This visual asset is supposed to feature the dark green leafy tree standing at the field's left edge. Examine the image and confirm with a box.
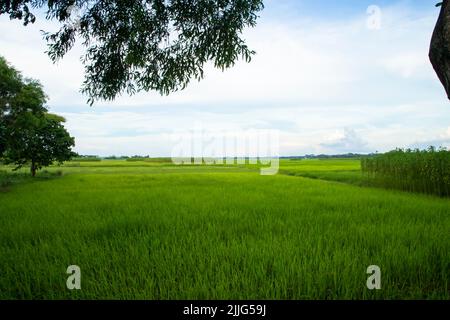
[0,57,75,176]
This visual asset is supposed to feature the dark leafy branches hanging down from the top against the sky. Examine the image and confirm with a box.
[0,0,263,104]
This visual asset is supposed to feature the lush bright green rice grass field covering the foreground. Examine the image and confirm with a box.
[0,160,450,299]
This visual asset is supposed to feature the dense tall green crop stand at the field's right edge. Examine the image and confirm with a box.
[361,147,450,196]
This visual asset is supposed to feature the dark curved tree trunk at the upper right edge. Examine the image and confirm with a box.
[429,0,450,99]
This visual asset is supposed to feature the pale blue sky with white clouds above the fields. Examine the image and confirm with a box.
[0,0,450,157]
